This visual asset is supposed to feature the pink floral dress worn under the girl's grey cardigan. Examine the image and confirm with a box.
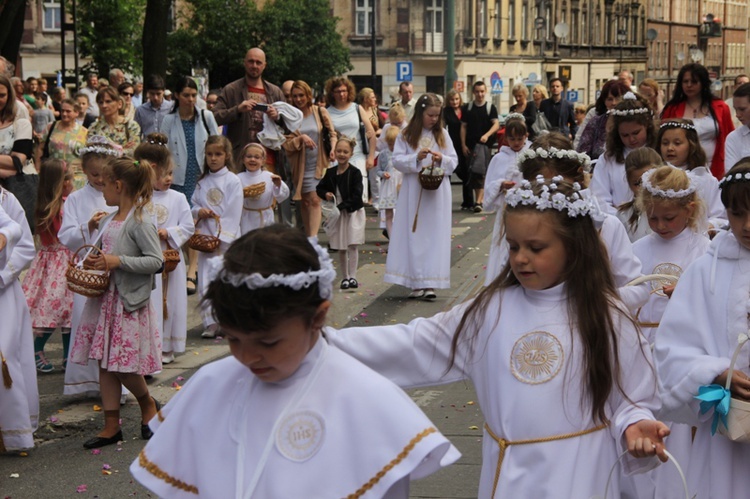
[70,220,161,375]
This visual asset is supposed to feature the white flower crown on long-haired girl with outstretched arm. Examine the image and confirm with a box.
[505,175,602,220]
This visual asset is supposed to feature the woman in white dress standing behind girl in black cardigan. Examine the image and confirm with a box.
[325,77,377,203]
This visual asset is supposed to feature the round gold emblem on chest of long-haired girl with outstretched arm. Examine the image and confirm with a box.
[510,331,565,385]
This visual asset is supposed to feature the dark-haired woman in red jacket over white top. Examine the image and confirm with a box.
[661,64,734,180]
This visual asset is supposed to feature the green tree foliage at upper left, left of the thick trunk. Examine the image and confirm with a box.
[75,0,146,77]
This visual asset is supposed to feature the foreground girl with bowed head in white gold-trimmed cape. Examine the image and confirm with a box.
[130,228,460,499]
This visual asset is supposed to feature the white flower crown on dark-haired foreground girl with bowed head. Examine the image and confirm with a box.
[207,237,336,300]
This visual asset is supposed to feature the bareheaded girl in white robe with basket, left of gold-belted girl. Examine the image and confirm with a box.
[191,135,242,338]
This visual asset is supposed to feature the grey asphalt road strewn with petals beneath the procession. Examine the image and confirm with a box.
[0,185,494,499]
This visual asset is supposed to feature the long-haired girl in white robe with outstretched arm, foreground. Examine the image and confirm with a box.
[326,177,669,499]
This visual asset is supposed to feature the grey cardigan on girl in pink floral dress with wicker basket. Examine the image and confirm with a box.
[99,212,164,312]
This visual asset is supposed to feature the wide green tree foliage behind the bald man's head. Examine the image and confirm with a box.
[168,0,352,88]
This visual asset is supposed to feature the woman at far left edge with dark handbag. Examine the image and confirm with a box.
[0,76,39,231]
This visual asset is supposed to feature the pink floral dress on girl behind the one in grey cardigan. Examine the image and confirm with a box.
[23,211,73,329]
